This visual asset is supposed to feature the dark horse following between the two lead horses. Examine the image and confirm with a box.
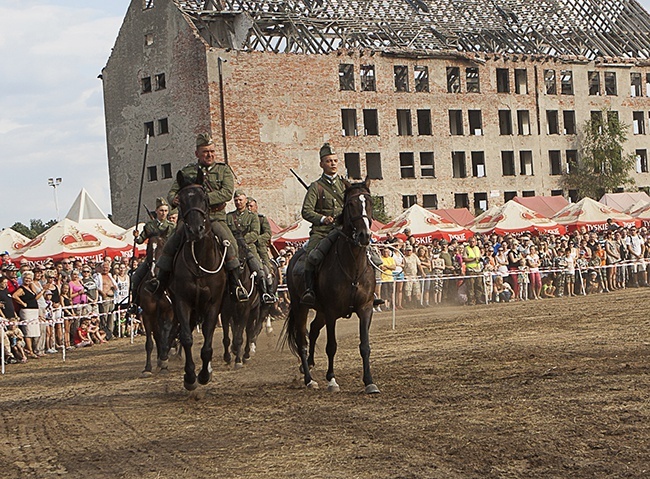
[221,238,261,369]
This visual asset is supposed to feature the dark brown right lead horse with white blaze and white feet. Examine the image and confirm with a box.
[283,179,379,394]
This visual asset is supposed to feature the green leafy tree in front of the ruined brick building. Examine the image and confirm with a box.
[564,108,635,200]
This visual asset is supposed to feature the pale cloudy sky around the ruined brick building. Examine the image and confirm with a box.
[0,0,650,229]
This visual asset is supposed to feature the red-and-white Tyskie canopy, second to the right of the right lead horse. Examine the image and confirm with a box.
[469,200,565,235]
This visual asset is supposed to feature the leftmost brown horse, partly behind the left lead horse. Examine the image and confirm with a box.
[138,231,175,377]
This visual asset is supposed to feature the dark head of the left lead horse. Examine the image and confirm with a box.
[176,168,211,241]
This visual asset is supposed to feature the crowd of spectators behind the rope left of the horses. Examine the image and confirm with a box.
[0,253,140,364]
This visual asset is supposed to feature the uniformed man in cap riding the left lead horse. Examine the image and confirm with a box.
[147,133,248,301]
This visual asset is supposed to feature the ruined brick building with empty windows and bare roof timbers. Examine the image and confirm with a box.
[102,0,650,226]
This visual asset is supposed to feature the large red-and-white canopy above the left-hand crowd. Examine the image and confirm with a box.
[16,218,132,263]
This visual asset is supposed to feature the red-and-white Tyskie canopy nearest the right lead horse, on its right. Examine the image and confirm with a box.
[377,204,473,244]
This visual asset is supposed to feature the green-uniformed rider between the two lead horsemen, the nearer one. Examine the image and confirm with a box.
[226,190,276,303]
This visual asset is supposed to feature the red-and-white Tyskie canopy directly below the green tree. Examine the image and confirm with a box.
[553,198,641,231]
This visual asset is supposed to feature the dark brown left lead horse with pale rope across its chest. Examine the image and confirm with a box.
[169,169,228,391]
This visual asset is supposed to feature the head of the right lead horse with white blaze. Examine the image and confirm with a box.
[342,178,372,246]
